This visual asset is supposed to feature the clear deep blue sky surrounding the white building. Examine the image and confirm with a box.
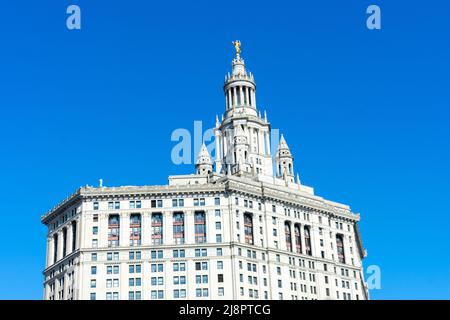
[0,0,450,299]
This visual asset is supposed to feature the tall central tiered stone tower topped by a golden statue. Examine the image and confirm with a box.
[215,41,273,177]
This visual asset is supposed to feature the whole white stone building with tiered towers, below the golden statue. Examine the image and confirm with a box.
[42,45,368,300]
